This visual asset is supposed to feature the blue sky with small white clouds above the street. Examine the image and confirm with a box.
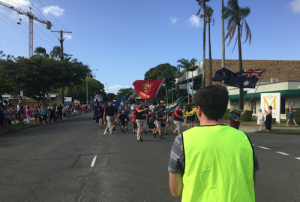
[0,0,300,93]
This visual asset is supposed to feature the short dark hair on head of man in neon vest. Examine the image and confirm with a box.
[195,85,229,121]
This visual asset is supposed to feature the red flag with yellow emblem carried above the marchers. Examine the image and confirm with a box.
[133,79,164,100]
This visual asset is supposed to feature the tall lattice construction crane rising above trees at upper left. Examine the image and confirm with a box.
[0,1,52,57]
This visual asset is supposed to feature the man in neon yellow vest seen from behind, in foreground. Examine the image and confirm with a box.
[168,85,259,202]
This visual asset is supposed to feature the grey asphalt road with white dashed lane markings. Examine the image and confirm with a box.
[0,113,300,202]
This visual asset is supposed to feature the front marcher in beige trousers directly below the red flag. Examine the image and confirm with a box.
[135,102,148,142]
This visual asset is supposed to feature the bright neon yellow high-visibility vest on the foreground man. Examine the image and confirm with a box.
[182,125,255,202]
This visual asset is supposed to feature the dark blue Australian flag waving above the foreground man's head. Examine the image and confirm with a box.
[213,68,265,88]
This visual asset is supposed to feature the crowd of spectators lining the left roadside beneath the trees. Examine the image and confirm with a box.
[0,102,93,134]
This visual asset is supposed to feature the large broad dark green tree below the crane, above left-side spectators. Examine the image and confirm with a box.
[5,55,89,104]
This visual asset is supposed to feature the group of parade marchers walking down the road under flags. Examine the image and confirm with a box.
[93,100,195,142]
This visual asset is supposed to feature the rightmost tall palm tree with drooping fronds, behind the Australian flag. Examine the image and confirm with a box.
[222,0,252,109]
